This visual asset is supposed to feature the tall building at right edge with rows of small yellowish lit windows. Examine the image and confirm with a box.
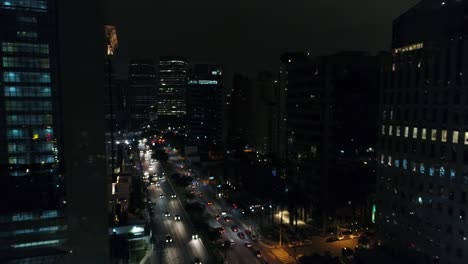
[375,0,468,264]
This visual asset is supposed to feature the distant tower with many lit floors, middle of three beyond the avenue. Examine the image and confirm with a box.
[156,56,189,130]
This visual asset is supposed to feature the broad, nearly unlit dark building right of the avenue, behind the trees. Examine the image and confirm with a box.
[279,52,378,227]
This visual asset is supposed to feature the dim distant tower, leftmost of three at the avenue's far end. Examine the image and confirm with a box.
[126,59,157,129]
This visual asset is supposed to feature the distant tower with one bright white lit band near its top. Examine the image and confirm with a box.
[186,64,223,146]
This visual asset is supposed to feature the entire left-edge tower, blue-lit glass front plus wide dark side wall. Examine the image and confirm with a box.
[0,0,108,264]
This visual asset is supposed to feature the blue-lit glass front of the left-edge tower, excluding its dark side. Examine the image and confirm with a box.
[0,0,68,263]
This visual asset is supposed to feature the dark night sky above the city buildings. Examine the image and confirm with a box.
[104,0,419,77]
